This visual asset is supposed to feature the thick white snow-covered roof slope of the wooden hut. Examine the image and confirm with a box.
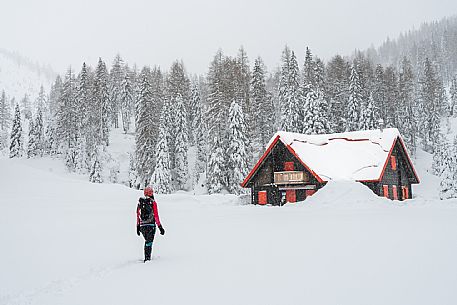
[268,128,401,181]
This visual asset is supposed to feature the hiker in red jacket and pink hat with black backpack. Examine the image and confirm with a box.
[136,186,165,262]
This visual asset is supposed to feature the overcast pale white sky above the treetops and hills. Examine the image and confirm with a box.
[0,0,457,73]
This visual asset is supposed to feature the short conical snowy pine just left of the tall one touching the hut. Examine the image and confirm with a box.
[206,133,227,194]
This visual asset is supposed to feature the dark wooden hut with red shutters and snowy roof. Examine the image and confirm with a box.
[241,128,419,205]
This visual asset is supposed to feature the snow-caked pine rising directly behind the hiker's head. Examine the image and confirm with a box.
[150,113,173,194]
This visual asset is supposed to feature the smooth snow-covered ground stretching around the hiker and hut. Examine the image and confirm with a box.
[0,153,457,305]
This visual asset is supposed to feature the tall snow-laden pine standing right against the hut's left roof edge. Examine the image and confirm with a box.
[227,101,248,194]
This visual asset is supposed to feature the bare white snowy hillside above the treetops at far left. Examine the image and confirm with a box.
[0,49,55,102]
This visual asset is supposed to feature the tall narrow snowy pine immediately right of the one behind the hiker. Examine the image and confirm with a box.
[174,93,189,190]
